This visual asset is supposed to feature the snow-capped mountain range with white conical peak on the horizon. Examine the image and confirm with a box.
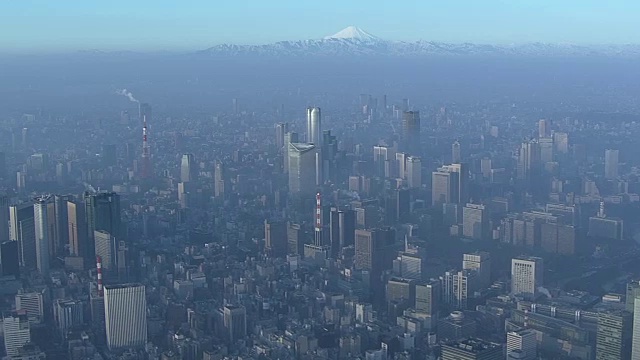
[197,26,640,58]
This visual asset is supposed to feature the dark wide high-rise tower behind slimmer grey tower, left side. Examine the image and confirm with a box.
[84,192,122,262]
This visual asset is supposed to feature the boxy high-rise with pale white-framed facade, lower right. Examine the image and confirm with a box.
[511,256,544,300]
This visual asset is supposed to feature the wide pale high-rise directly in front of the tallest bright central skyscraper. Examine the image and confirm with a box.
[289,143,317,196]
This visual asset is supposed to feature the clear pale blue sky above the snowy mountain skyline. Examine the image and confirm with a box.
[0,0,640,52]
